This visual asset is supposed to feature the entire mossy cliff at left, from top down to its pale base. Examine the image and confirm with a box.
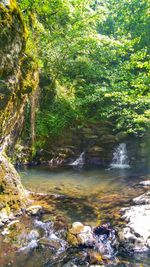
[0,0,38,214]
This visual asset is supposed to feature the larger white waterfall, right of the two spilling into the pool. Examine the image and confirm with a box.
[110,143,130,169]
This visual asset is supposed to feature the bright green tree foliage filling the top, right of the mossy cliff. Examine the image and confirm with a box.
[19,0,150,144]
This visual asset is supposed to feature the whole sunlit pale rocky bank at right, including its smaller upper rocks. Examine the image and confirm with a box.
[119,180,150,253]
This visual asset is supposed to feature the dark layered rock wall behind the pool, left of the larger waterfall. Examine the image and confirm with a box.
[36,122,118,166]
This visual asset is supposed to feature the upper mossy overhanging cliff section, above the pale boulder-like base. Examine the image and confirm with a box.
[0,0,38,150]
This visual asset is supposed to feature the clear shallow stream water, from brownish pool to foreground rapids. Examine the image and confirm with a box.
[0,163,150,267]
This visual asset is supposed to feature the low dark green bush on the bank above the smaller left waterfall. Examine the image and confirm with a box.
[36,98,77,146]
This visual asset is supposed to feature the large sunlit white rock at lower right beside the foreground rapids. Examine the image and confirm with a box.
[119,205,150,252]
